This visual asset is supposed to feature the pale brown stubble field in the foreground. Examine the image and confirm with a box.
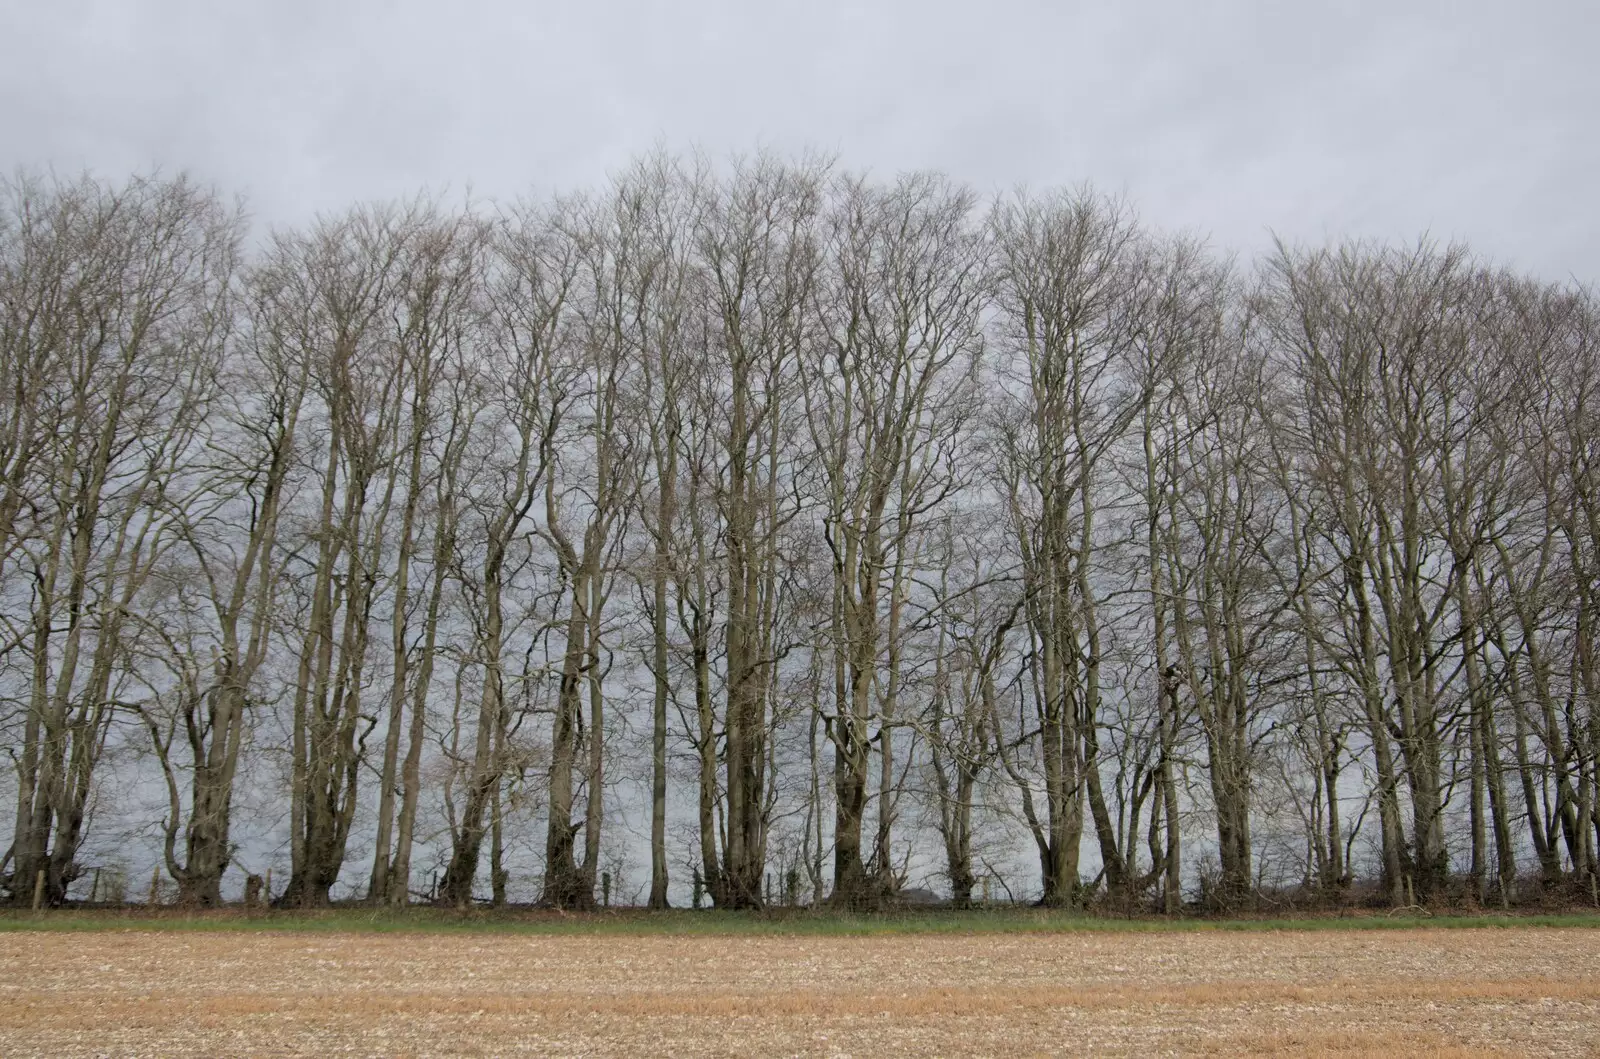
[0,928,1600,1059]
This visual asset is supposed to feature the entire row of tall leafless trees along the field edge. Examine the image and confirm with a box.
[0,155,1600,910]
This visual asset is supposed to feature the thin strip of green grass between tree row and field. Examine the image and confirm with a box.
[0,909,1600,937]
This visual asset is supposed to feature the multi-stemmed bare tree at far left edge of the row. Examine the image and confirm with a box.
[0,178,240,904]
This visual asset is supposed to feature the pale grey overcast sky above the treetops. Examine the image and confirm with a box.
[0,0,1600,282]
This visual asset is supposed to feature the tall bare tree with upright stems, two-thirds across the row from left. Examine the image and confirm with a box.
[989,190,1142,905]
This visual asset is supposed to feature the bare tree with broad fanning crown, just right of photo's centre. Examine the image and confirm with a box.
[803,174,984,907]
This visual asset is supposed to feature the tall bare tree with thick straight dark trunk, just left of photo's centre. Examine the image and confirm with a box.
[694,158,822,909]
